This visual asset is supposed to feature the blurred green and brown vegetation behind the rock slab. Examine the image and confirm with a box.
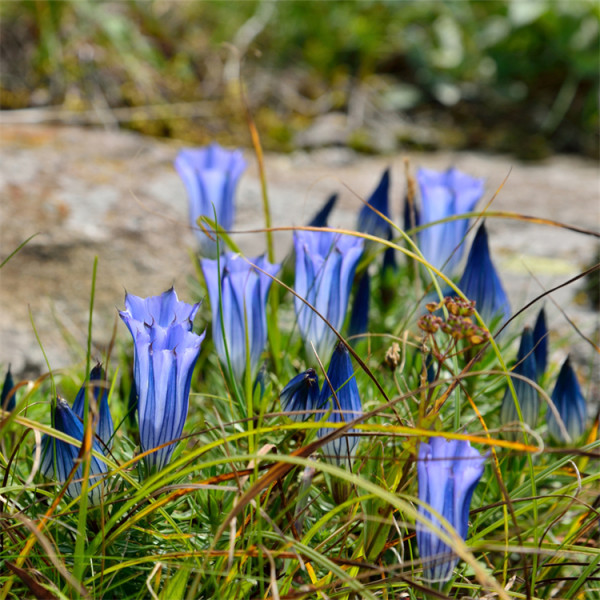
[0,0,600,158]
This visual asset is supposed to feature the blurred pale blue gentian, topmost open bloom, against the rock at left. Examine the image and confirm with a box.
[175,144,246,256]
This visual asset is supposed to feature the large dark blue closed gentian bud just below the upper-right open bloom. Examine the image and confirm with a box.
[458,223,510,327]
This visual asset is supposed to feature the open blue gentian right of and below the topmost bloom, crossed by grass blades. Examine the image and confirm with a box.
[201,252,280,380]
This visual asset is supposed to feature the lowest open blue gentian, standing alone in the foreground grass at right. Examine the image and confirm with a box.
[417,437,486,583]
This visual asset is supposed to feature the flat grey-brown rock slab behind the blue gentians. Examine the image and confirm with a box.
[0,123,600,398]
